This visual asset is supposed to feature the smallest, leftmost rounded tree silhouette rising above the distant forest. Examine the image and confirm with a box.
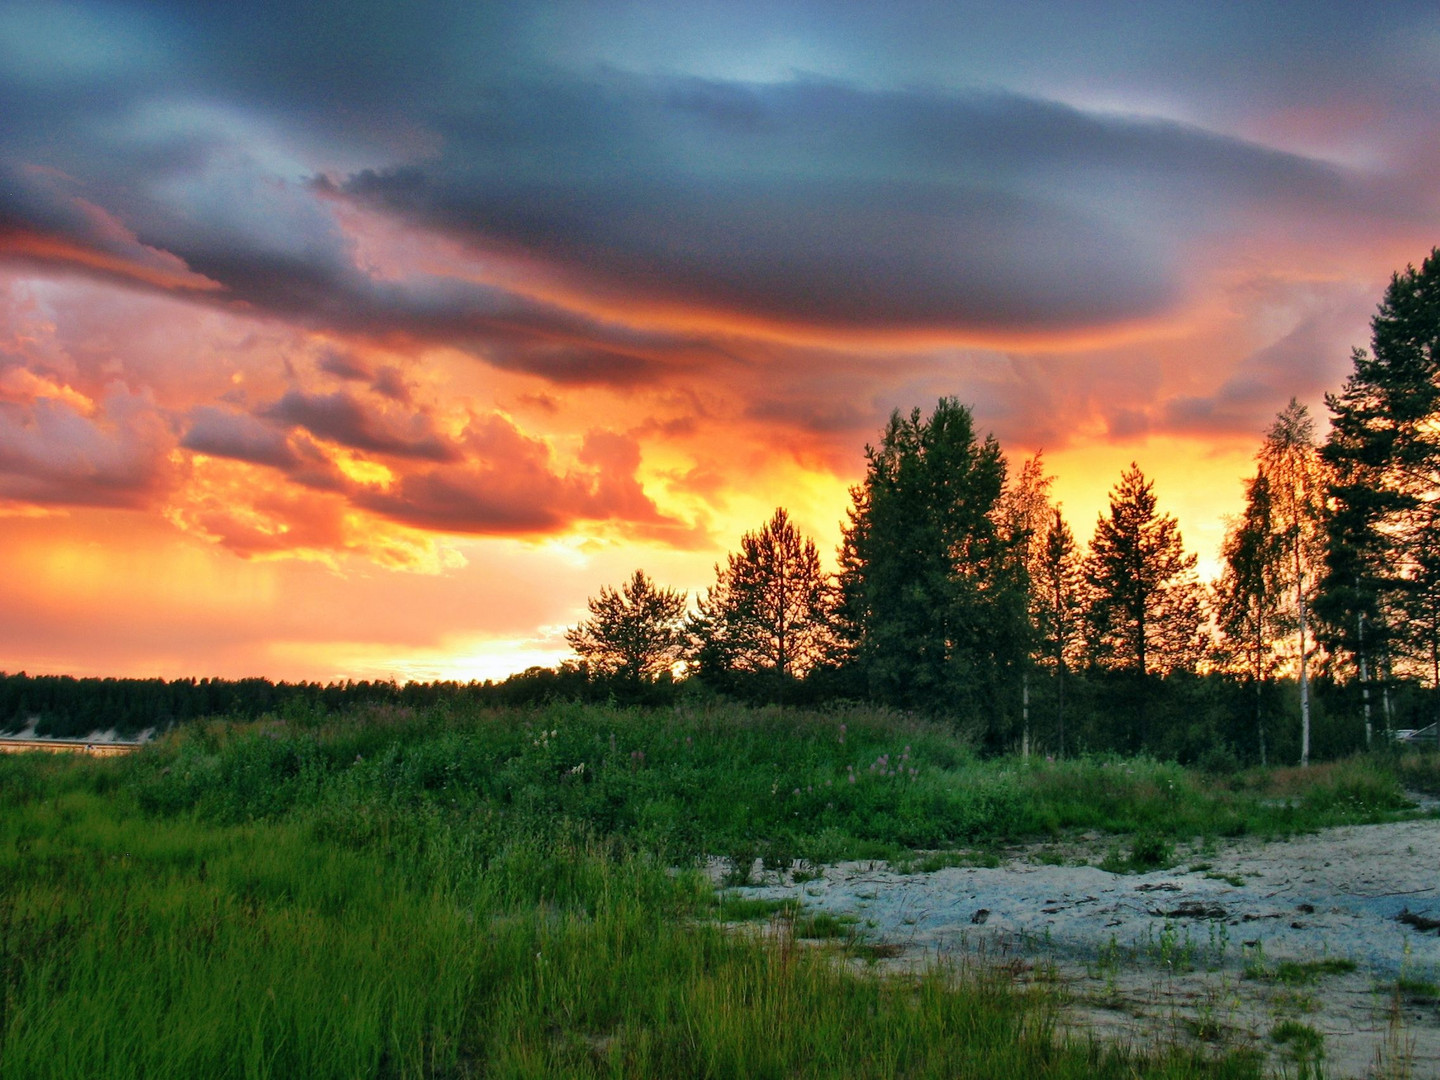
[564,570,685,683]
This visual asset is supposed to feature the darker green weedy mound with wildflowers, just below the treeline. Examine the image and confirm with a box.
[109,706,1407,864]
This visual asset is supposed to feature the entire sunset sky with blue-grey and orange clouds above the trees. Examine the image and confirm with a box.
[0,0,1440,681]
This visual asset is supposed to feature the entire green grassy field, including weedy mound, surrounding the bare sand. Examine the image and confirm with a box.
[0,706,1433,1080]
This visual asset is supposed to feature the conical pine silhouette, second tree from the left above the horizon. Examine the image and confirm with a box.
[691,508,835,681]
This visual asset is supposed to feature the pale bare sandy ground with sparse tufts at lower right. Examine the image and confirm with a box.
[731,819,1440,1077]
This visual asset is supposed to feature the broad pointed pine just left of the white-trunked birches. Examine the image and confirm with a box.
[1084,462,1202,675]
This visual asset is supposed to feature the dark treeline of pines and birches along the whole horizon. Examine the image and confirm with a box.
[8,251,1440,768]
